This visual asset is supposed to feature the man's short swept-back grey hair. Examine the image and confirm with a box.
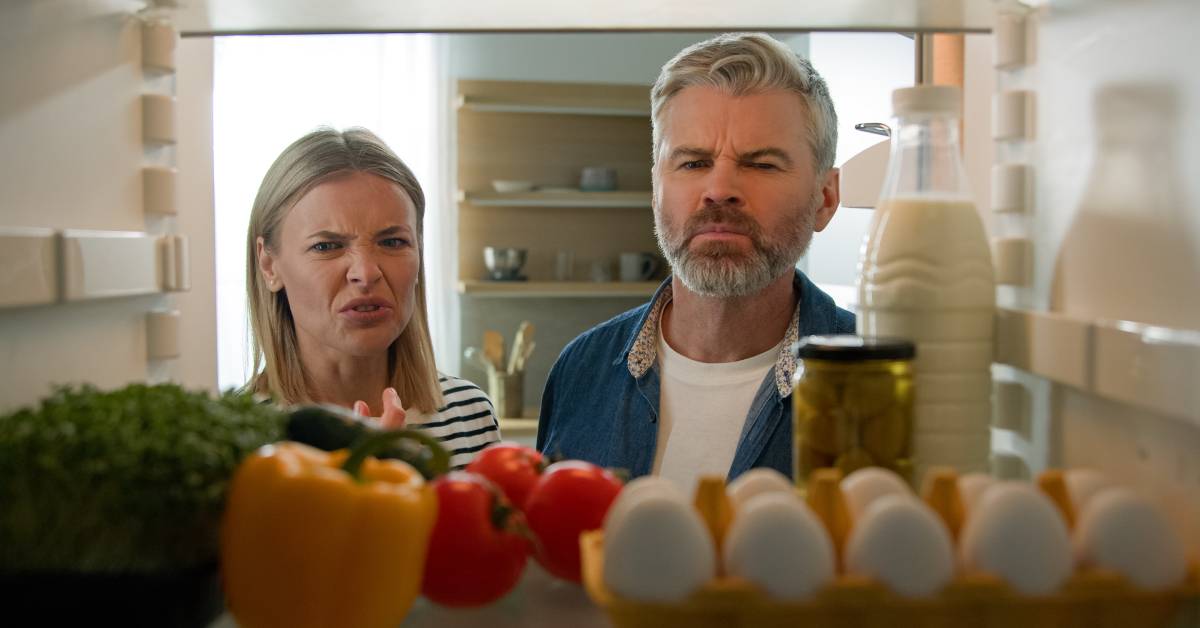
[650,32,838,172]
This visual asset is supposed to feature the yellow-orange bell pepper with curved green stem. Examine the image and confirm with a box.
[221,430,449,628]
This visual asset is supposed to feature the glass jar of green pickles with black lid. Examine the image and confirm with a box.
[792,335,917,488]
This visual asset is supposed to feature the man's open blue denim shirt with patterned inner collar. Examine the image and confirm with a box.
[538,270,854,480]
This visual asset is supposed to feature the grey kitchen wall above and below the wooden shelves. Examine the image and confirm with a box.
[448,32,808,417]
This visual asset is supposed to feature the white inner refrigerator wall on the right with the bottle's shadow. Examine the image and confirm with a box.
[1022,0,1200,557]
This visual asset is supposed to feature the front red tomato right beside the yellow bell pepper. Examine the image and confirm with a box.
[421,471,529,606]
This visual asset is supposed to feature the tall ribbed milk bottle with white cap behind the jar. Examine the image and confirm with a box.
[858,85,996,485]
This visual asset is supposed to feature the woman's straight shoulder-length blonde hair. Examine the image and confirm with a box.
[246,127,442,413]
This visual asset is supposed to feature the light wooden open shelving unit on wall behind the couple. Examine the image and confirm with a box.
[457,80,658,291]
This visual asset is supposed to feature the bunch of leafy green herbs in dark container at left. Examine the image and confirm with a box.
[0,384,284,573]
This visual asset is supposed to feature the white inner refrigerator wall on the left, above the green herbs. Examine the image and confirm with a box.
[0,0,216,412]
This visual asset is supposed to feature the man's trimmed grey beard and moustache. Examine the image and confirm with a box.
[654,189,821,298]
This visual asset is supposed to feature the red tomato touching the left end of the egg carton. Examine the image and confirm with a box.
[526,460,622,582]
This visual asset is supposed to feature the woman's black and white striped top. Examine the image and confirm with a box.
[406,373,500,468]
